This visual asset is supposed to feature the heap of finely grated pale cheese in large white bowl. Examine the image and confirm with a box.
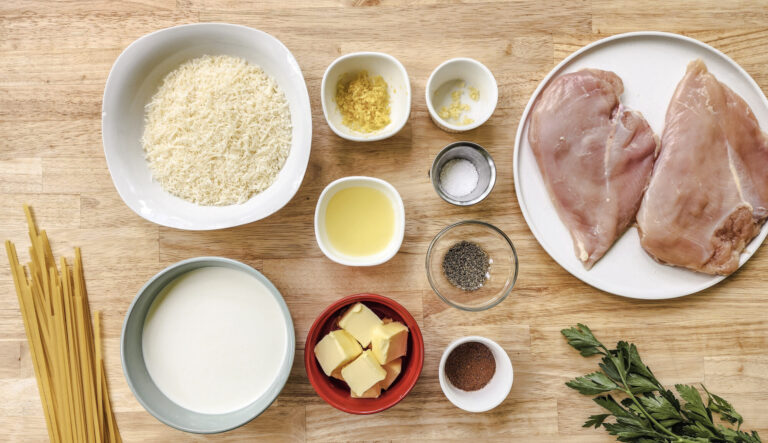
[142,55,292,206]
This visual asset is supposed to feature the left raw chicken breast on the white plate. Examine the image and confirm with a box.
[528,69,658,269]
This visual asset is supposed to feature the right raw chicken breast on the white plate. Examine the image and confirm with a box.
[637,60,768,275]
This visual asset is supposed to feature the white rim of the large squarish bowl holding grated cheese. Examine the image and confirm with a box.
[101,22,312,231]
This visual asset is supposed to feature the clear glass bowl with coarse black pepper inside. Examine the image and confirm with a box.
[426,220,518,311]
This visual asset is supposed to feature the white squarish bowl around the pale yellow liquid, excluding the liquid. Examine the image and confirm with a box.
[315,176,405,266]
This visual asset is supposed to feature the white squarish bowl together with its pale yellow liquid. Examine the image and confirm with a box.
[315,176,405,266]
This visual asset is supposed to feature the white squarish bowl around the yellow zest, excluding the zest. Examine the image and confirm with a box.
[321,52,411,142]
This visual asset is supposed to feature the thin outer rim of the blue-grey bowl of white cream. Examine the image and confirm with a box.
[120,256,296,434]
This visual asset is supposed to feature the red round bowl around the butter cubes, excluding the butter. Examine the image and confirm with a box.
[304,294,424,414]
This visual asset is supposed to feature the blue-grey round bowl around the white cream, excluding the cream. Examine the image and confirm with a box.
[120,257,296,434]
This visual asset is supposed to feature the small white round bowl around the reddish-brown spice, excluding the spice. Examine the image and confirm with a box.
[439,335,514,412]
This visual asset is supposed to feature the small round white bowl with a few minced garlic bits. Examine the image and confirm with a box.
[426,58,499,132]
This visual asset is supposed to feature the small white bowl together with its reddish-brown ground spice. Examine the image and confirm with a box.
[439,335,514,412]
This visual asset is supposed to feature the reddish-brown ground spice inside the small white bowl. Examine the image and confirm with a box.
[445,341,496,391]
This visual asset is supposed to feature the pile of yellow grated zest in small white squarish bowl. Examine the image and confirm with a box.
[336,71,391,132]
